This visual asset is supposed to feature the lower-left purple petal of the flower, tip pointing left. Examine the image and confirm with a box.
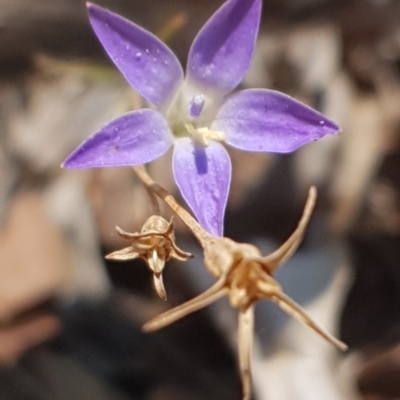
[63,109,173,168]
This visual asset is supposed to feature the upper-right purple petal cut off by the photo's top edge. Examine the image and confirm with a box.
[187,0,261,95]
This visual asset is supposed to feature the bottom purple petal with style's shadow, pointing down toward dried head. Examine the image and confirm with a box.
[172,138,231,236]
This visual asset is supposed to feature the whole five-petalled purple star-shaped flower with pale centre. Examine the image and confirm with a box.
[64,0,339,236]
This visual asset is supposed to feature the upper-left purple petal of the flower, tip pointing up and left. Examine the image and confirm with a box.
[88,4,183,107]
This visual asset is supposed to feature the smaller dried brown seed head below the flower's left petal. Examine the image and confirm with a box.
[106,215,193,300]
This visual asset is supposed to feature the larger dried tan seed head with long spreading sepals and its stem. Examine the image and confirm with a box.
[136,169,347,400]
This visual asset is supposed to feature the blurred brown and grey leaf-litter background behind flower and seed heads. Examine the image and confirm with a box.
[0,0,400,400]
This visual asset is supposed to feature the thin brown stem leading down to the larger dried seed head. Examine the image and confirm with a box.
[133,165,212,246]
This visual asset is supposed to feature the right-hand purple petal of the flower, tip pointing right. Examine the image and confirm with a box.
[211,89,340,153]
